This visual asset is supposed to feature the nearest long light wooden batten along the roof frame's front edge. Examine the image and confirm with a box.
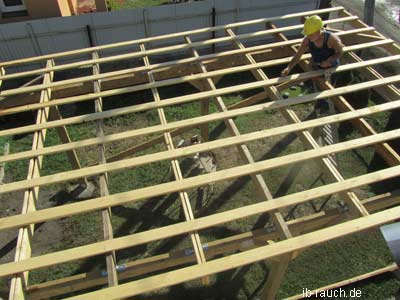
[57,207,400,300]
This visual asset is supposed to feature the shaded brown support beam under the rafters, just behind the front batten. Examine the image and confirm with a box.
[28,192,400,300]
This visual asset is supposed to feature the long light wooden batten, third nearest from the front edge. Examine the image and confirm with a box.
[0,129,400,230]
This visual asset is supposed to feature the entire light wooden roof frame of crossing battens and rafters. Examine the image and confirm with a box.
[0,7,400,299]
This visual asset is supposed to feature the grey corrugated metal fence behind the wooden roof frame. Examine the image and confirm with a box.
[0,0,319,71]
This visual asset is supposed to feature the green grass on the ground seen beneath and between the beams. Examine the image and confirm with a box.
[0,68,399,299]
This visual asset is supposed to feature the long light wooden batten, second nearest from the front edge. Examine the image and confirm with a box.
[0,162,400,277]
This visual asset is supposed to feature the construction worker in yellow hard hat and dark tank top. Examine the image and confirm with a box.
[282,15,343,110]
